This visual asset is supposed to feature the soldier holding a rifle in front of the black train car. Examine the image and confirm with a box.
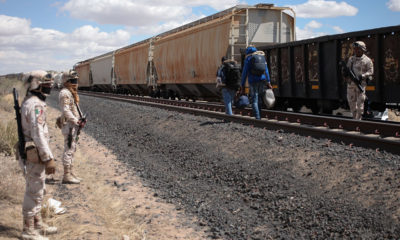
[347,41,374,120]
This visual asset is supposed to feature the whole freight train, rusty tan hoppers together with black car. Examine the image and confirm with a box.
[74,4,400,113]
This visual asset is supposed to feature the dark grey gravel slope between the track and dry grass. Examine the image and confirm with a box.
[49,94,400,239]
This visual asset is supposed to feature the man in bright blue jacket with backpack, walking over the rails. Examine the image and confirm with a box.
[240,46,272,119]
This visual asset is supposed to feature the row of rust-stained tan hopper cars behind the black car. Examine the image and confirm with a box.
[74,4,296,99]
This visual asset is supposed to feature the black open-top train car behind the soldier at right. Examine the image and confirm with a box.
[259,26,400,113]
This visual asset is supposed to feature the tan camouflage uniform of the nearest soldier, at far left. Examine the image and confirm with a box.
[19,93,57,240]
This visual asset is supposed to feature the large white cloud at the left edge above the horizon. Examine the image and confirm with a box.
[0,15,130,74]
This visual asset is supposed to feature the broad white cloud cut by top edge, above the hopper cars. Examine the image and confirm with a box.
[60,0,239,36]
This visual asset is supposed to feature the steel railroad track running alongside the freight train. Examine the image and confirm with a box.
[80,91,400,154]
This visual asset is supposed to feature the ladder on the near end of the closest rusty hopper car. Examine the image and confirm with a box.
[229,8,249,62]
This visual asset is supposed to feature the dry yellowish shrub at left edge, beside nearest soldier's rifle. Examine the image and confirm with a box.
[0,120,18,156]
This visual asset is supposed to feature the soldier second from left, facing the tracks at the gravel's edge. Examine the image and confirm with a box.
[57,71,85,184]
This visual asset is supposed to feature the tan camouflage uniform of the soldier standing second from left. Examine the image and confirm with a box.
[59,88,80,183]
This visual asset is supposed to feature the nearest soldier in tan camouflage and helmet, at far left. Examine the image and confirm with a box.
[18,70,57,240]
